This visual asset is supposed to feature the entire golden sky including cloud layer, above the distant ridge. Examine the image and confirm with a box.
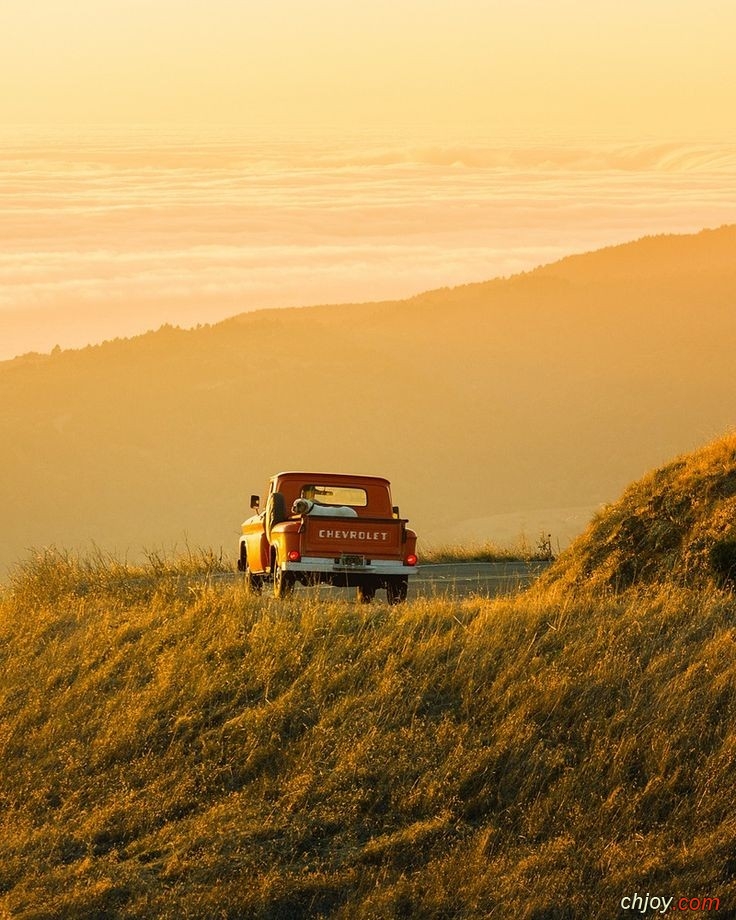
[0,0,736,360]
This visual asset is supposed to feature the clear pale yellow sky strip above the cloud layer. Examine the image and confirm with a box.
[0,0,736,139]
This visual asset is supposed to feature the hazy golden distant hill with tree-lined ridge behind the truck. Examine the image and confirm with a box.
[0,226,736,565]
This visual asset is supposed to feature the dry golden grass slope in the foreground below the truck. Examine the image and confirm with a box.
[0,554,736,920]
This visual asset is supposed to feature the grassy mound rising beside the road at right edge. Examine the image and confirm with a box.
[542,434,736,589]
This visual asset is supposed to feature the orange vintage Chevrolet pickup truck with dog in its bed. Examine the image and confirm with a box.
[238,473,417,604]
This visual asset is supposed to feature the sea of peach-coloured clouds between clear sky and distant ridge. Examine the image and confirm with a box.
[0,128,736,359]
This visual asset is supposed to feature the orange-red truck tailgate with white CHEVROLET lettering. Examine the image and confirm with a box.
[301,516,404,560]
